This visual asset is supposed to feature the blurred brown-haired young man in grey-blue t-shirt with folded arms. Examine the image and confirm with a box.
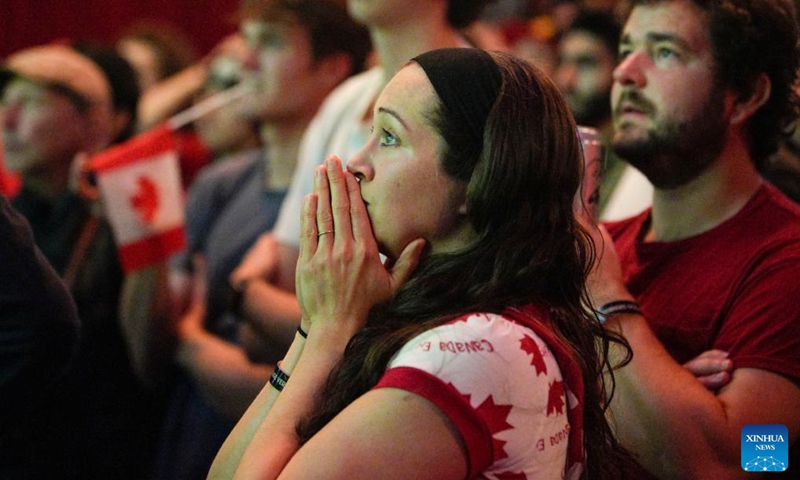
[126,0,370,480]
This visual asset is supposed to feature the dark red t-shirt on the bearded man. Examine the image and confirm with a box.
[606,183,800,479]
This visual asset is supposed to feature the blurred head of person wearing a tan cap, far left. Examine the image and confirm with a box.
[2,45,112,188]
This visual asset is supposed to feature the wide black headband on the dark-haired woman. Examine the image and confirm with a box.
[411,48,503,156]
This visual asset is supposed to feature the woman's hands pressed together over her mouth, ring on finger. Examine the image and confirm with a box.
[296,156,425,342]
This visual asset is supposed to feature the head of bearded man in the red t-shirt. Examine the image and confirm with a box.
[612,0,799,188]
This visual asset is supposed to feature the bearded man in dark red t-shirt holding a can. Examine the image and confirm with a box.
[591,0,800,480]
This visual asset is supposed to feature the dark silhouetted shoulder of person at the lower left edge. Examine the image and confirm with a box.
[0,196,79,472]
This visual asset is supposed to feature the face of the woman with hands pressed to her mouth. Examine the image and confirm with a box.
[347,63,476,258]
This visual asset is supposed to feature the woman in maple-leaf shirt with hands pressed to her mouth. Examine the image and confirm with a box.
[209,48,624,479]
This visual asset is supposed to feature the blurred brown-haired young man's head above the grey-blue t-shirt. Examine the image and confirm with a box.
[238,0,370,123]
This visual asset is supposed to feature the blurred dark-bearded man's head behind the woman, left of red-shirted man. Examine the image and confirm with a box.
[553,10,621,127]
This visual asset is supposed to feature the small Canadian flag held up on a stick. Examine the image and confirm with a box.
[90,125,186,272]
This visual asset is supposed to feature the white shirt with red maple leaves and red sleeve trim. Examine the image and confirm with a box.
[376,308,584,479]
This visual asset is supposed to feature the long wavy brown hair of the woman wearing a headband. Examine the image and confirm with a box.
[298,53,630,479]
